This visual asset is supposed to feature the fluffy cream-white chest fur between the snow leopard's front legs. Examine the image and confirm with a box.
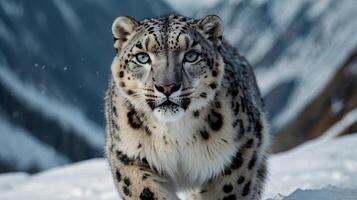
[140,112,237,187]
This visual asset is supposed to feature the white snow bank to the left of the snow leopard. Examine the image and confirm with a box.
[0,159,118,200]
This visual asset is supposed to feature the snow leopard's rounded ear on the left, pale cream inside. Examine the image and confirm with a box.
[112,16,139,51]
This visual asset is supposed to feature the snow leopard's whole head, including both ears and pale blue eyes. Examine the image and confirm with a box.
[112,15,224,121]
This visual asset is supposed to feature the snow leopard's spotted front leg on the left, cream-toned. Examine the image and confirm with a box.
[108,152,179,200]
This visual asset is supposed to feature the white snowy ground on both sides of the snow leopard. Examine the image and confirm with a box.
[0,134,357,200]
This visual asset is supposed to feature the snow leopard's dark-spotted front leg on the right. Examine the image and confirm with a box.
[187,142,266,200]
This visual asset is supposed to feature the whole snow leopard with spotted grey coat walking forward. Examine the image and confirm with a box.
[105,14,269,200]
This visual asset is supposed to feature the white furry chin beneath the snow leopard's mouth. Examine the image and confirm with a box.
[153,101,185,122]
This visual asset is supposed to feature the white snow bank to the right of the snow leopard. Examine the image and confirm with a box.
[265,135,357,198]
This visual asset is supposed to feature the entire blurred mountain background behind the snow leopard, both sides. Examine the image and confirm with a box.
[0,0,357,172]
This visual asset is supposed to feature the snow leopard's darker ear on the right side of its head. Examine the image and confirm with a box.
[197,15,224,46]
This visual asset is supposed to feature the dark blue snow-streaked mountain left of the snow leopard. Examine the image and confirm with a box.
[0,0,172,172]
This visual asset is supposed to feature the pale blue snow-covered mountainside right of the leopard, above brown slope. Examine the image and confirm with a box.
[186,0,357,133]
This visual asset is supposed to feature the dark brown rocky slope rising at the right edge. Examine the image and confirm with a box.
[272,52,357,152]
